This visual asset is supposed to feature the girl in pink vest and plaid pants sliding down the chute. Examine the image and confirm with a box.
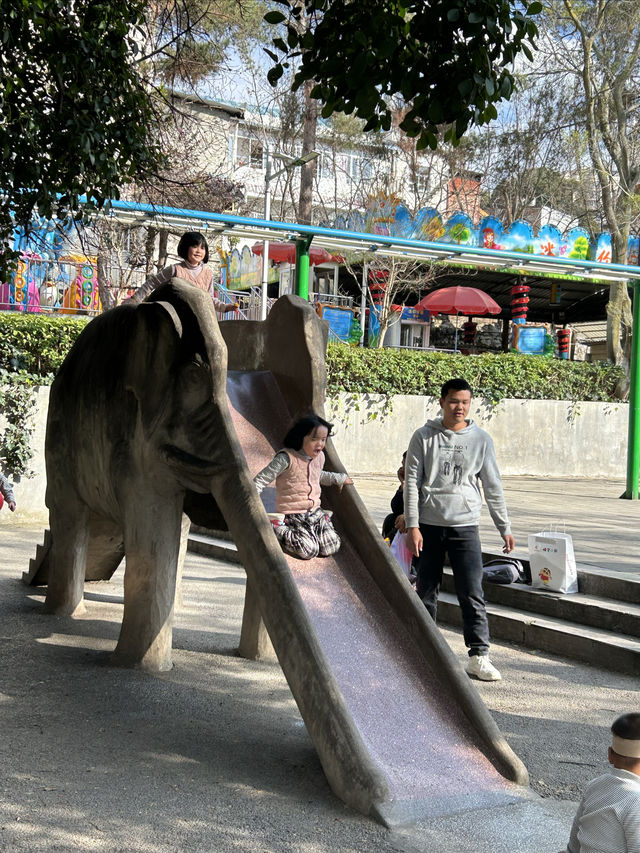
[253,414,353,560]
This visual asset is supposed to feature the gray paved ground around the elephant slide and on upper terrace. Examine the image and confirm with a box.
[0,477,640,853]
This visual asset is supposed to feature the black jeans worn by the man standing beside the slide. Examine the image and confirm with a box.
[416,524,489,656]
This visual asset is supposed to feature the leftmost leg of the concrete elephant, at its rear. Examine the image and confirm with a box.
[44,488,89,616]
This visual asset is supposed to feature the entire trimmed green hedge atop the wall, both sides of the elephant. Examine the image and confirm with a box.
[0,312,623,402]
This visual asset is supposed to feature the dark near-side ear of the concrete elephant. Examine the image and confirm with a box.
[125,301,183,435]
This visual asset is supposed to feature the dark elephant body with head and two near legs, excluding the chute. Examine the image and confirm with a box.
[45,279,262,670]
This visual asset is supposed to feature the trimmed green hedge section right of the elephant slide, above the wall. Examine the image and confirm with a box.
[327,344,624,403]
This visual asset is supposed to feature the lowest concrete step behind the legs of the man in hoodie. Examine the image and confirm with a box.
[438,584,640,675]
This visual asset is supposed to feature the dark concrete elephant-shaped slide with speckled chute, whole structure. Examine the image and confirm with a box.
[27,279,528,825]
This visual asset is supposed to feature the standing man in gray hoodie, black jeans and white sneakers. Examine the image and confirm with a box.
[404,379,514,681]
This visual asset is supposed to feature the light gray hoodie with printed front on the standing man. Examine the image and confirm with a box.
[404,418,511,536]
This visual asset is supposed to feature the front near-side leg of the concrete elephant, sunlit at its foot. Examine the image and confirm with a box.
[115,491,182,672]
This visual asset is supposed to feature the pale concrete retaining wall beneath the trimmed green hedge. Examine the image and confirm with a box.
[0,387,628,527]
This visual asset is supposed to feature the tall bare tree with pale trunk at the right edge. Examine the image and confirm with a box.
[545,0,640,395]
